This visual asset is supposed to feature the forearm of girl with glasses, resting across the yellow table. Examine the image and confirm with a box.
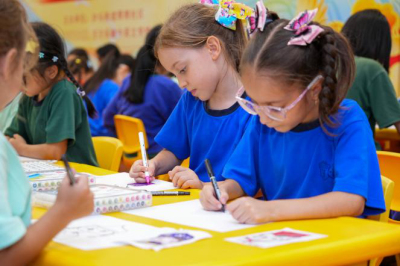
[266,192,365,221]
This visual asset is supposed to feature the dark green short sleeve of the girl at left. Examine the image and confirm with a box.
[45,87,83,143]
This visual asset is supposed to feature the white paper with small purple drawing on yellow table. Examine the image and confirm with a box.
[127,227,211,251]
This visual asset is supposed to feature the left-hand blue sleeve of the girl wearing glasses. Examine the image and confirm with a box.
[222,117,260,196]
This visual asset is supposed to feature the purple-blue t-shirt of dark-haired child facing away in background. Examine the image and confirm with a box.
[103,75,182,154]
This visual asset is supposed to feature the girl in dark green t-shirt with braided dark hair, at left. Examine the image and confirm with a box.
[5,22,97,166]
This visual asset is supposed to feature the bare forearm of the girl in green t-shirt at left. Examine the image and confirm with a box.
[18,144,67,160]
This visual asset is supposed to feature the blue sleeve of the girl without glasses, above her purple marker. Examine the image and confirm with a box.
[155,92,190,160]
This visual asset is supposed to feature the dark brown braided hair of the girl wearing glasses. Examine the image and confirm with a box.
[241,19,355,131]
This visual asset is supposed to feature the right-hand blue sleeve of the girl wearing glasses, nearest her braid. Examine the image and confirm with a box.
[333,117,385,215]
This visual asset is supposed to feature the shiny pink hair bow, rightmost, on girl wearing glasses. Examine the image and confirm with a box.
[285,8,324,46]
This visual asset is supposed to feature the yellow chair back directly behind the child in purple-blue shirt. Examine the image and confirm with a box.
[114,115,149,169]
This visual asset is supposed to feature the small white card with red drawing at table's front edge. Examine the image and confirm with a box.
[225,228,327,248]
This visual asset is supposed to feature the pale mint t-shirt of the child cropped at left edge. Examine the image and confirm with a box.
[0,133,31,250]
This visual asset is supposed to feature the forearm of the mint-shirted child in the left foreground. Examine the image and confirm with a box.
[0,206,71,265]
